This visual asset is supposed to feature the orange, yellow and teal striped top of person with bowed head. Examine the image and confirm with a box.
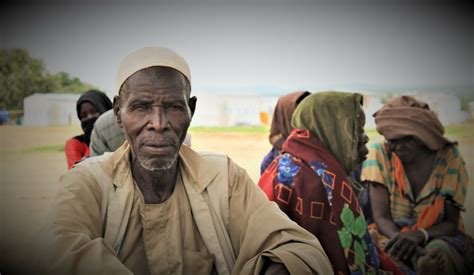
[361,142,469,229]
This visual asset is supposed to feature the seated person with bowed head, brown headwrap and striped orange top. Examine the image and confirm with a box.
[361,96,474,274]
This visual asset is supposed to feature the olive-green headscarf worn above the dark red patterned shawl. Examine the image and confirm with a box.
[291,91,365,173]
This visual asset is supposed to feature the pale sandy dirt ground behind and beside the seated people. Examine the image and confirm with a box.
[0,126,474,273]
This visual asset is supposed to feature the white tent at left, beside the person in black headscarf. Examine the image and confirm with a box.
[23,94,80,126]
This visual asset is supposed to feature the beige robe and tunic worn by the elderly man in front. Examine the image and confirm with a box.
[39,143,332,274]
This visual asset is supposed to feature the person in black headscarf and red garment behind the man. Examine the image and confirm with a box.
[64,90,112,169]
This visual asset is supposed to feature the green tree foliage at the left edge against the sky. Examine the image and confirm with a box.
[0,49,95,110]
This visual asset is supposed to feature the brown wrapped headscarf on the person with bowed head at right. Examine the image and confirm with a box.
[373,95,455,151]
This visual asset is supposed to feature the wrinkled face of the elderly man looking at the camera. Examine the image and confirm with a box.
[116,67,195,171]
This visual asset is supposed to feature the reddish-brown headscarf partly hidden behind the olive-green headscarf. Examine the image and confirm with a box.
[269,91,311,150]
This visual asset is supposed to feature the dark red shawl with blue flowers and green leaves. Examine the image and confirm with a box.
[259,129,400,274]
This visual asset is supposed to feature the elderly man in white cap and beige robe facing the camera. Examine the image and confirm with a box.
[37,47,332,274]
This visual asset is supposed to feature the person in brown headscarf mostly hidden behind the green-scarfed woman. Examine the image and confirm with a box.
[260,92,311,175]
